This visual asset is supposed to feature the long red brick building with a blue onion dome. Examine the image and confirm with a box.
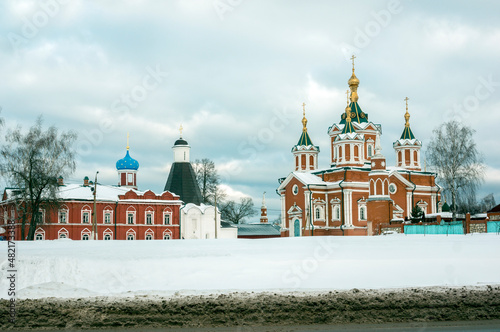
[0,147,183,240]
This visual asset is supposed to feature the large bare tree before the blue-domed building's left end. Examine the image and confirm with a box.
[0,117,76,240]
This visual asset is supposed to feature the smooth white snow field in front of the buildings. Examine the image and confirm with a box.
[0,234,500,298]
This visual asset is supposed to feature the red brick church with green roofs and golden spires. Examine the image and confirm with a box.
[277,57,441,237]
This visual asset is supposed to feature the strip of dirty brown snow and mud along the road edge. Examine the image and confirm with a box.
[0,286,500,331]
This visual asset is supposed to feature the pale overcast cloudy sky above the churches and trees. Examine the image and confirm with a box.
[0,0,500,220]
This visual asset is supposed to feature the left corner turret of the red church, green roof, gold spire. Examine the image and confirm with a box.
[292,103,319,172]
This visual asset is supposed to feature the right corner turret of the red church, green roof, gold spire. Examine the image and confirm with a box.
[393,97,422,171]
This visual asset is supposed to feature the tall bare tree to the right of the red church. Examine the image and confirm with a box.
[427,120,484,221]
